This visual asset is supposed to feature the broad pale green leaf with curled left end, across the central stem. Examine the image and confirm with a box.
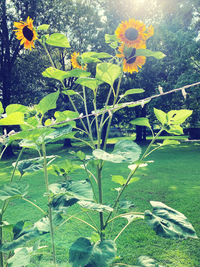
[93,140,141,163]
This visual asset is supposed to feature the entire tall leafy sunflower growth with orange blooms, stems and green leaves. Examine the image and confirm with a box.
[0,17,197,267]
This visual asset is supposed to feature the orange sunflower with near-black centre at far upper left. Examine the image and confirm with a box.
[14,17,37,50]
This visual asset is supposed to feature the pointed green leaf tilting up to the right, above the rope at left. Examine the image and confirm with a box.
[36,90,59,115]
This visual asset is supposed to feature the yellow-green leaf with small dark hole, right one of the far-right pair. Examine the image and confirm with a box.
[167,109,193,125]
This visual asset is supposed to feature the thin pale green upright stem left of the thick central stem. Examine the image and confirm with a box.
[42,142,56,266]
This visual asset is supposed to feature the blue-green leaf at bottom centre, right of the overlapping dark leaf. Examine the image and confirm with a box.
[85,240,117,267]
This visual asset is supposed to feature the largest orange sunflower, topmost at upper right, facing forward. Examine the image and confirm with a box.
[115,19,154,49]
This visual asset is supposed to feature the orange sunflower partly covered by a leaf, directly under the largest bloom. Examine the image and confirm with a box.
[117,44,146,74]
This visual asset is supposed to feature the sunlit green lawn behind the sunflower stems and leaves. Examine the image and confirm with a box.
[0,139,200,267]
